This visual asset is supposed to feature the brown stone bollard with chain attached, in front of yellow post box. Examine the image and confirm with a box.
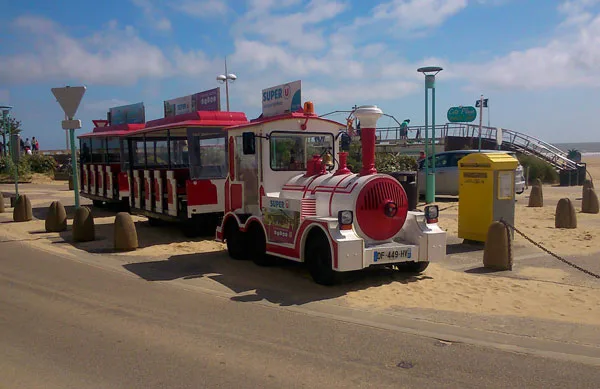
[483,222,513,270]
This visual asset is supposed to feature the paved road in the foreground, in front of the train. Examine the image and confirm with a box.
[0,242,600,389]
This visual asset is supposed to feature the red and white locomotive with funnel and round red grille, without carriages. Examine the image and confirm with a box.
[217,102,446,285]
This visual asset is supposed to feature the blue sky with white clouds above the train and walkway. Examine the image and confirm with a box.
[0,0,600,149]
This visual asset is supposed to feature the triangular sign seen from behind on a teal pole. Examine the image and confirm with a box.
[52,86,85,208]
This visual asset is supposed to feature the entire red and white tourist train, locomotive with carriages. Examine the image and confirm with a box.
[79,81,446,285]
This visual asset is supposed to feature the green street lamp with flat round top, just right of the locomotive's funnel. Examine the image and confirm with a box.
[417,66,444,204]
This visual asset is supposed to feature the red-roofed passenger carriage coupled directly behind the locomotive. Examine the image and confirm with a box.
[125,111,248,236]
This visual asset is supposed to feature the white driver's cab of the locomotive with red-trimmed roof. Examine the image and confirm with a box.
[228,111,345,215]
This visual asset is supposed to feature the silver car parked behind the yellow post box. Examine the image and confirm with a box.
[419,150,525,196]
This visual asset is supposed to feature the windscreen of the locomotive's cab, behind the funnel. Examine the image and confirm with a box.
[270,132,333,171]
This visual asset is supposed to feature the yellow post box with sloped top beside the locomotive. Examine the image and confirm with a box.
[458,153,518,242]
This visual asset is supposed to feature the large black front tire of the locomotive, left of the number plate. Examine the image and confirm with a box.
[304,232,339,286]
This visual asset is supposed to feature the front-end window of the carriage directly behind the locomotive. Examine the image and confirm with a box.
[190,134,227,178]
